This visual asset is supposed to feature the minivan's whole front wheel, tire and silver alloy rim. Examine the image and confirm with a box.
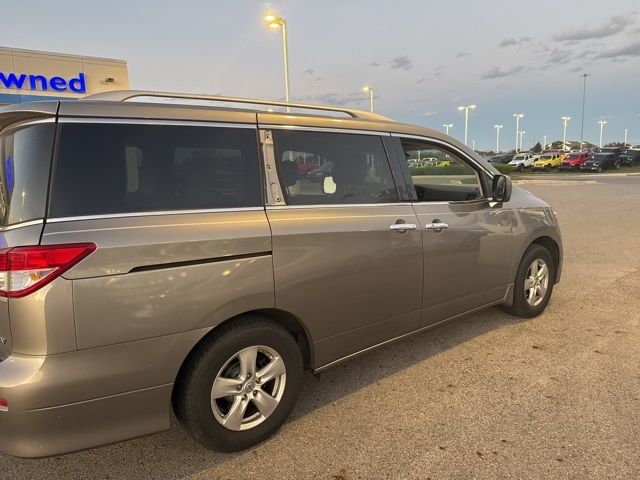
[506,244,555,318]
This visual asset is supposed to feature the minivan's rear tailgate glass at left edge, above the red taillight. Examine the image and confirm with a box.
[0,123,54,227]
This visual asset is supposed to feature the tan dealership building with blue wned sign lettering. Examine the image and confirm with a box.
[0,47,129,106]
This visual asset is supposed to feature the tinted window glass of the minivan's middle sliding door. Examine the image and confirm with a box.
[273,130,398,205]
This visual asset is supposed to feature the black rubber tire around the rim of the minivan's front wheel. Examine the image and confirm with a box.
[505,244,556,318]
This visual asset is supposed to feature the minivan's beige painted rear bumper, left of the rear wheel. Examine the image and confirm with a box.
[0,330,206,457]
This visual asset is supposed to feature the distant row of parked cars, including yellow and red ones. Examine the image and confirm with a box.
[488,146,640,172]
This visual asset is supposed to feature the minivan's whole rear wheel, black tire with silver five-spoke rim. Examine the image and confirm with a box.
[173,315,303,452]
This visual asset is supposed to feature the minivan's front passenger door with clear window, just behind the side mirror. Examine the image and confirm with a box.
[400,138,513,326]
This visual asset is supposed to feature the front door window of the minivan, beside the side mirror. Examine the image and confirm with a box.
[402,139,482,202]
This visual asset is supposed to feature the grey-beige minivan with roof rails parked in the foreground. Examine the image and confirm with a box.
[0,91,562,457]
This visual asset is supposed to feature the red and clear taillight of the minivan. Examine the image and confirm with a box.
[0,243,96,297]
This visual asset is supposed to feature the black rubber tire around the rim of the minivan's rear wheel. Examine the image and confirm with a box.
[173,315,303,452]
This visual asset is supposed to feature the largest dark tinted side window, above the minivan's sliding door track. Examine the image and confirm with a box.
[50,123,262,217]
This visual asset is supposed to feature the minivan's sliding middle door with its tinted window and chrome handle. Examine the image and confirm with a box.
[262,126,423,367]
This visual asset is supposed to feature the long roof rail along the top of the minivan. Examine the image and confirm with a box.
[80,90,391,121]
